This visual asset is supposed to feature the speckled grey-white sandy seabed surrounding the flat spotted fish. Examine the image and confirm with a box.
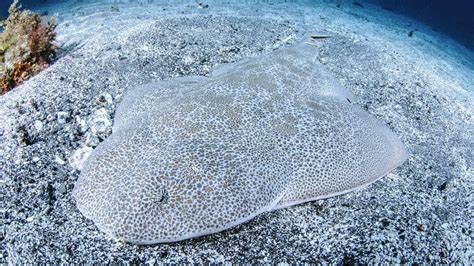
[0,1,474,264]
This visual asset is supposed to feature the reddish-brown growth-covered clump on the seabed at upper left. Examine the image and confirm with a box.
[0,0,59,95]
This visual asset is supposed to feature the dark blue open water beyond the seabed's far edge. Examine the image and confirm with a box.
[0,0,474,50]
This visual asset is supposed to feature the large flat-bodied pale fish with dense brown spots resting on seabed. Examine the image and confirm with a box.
[73,38,407,244]
